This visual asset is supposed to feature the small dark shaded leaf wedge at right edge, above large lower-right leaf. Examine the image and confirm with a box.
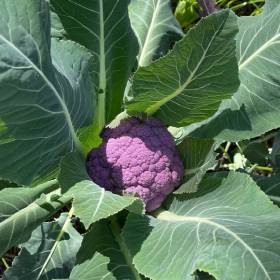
[253,175,280,206]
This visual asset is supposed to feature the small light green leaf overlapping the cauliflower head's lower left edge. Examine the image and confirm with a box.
[67,181,143,231]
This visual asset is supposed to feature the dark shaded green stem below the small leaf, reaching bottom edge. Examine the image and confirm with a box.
[111,216,141,280]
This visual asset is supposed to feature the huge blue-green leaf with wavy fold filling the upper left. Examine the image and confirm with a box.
[0,0,94,185]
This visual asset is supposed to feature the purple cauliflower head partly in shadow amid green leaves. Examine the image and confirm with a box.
[86,117,184,211]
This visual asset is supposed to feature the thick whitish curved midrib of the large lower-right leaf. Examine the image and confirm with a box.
[156,211,272,280]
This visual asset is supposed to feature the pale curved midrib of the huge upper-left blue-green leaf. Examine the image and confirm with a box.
[0,34,80,148]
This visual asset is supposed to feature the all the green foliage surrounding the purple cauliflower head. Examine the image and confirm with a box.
[0,0,280,280]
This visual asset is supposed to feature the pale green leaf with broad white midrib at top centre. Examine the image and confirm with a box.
[129,0,183,67]
